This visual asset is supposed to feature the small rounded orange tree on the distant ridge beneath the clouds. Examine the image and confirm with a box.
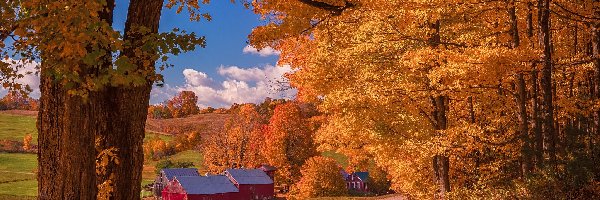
[167,91,200,118]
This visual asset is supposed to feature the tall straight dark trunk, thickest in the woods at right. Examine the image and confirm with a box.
[538,0,556,164]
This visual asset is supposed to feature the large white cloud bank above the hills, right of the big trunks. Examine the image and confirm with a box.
[157,65,296,108]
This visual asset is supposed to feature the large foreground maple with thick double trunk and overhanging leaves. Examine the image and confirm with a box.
[0,0,207,199]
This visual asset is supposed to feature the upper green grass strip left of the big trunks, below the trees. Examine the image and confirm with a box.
[0,113,37,144]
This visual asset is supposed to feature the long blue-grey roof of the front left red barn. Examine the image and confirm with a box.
[175,175,239,194]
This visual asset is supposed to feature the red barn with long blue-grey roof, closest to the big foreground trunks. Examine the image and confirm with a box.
[162,176,245,200]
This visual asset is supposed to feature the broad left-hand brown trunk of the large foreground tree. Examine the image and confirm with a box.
[37,0,114,200]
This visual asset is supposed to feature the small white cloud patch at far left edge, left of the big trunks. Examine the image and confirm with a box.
[0,58,40,98]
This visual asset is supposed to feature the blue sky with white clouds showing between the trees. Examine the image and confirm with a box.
[0,0,295,107]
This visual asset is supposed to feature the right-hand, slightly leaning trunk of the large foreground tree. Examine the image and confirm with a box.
[99,0,163,200]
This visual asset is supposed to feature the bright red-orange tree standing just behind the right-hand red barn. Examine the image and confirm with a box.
[262,102,317,186]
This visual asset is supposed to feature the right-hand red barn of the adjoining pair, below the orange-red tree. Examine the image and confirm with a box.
[225,169,275,200]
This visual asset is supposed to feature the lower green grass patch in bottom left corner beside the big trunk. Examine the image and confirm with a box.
[0,153,37,199]
